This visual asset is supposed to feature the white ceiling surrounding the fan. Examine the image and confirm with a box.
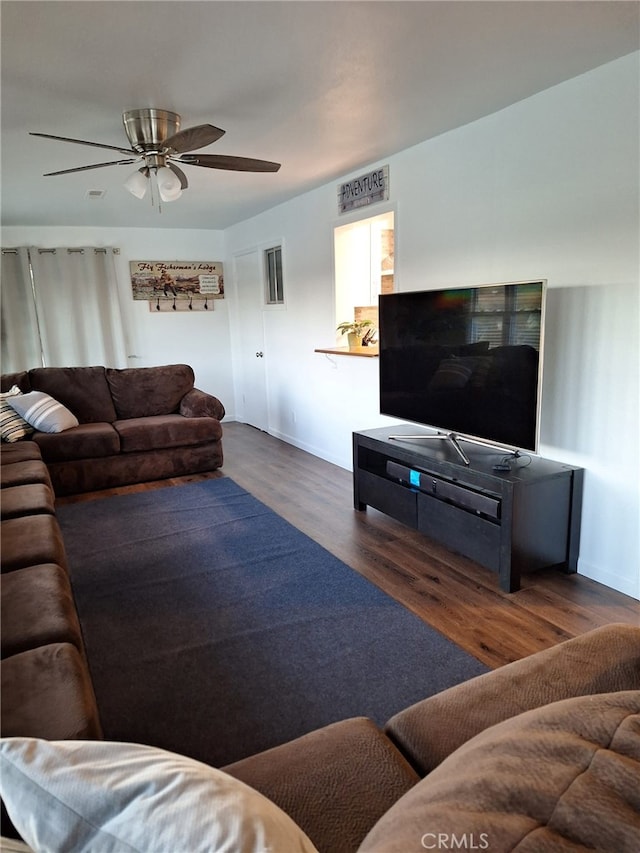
[0,0,640,229]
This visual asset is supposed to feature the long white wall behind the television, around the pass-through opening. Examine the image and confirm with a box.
[225,53,640,597]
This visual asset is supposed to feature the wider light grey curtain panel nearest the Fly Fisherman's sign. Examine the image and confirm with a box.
[3,247,127,372]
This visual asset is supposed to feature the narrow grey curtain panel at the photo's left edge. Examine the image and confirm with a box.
[0,248,44,373]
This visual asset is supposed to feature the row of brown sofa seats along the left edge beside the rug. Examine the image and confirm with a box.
[0,442,101,738]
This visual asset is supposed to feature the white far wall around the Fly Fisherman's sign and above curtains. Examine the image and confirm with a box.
[2,226,235,417]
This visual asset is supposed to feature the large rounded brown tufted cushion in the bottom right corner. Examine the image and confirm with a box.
[360,691,640,853]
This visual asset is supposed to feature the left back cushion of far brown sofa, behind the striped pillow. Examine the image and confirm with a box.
[29,367,116,424]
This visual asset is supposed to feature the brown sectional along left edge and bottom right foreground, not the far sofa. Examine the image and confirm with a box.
[0,450,640,853]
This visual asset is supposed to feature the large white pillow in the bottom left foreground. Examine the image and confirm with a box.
[0,738,317,853]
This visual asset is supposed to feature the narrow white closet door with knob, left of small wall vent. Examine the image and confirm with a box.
[233,250,269,431]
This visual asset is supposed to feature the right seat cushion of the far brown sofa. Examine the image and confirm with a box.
[113,415,222,453]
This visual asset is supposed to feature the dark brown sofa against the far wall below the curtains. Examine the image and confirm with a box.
[1,364,224,495]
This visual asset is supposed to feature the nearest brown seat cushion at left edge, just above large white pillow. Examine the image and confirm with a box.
[0,643,102,740]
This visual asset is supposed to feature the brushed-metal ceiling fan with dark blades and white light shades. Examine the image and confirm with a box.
[30,108,280,201]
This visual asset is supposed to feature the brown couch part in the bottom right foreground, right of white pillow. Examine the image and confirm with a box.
[224,624,640,853]
